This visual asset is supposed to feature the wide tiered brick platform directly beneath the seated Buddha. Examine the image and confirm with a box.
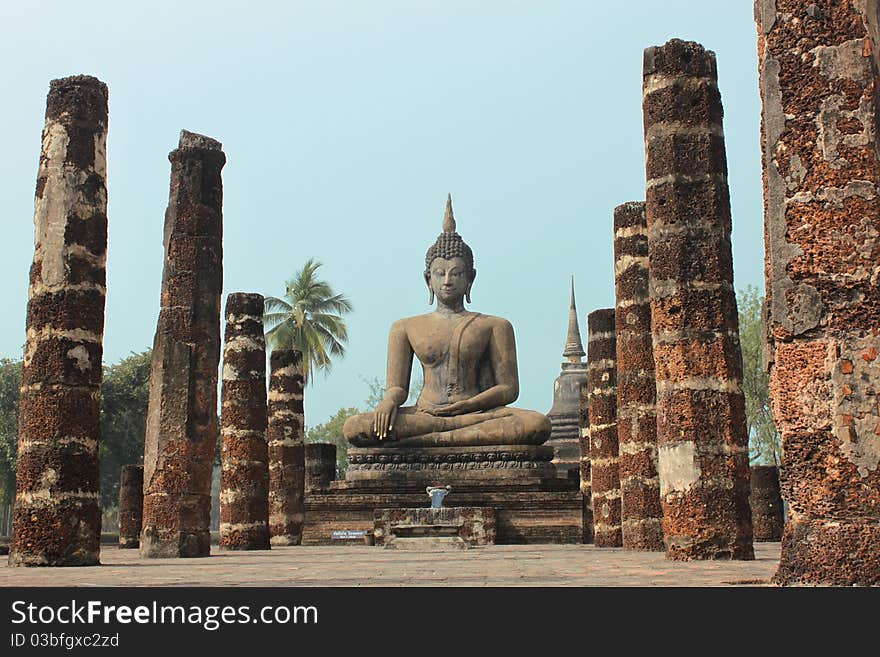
[303,445,583,545]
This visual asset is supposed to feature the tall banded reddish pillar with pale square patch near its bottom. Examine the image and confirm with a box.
[643,39,754,560]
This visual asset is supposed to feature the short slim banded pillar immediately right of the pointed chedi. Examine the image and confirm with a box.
[587,308,622,547]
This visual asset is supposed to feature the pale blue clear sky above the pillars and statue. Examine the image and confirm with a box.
[0,0,763,425]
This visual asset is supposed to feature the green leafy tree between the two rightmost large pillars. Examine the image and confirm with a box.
[736,285,782,465]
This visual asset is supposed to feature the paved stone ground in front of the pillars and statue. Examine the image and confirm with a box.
[0,543,780,587]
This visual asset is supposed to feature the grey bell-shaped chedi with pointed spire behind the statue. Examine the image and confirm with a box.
[547,276,587,476]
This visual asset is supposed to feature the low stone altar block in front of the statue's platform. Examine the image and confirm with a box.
[373,506,496,550]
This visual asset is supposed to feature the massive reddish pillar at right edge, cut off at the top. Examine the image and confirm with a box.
[755,0,880,585]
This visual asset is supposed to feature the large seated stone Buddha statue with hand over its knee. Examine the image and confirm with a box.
[343,197,551,447]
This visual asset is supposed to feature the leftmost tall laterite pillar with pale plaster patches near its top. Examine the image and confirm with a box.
[9,75,107,566]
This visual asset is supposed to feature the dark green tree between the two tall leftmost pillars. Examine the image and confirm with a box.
[101,349,152,508]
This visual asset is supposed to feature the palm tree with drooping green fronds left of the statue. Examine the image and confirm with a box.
[263,258,352,382]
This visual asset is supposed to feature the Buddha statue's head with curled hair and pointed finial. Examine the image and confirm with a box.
[425,194,477,304]
